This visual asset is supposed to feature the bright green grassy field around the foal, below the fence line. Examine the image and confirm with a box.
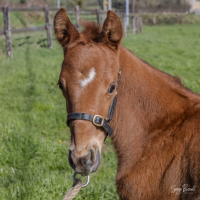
[0,24,200,200]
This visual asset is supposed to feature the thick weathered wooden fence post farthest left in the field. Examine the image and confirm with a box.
[3,6,13,58]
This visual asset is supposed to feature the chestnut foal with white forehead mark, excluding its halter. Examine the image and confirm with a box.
[54,9,200,200]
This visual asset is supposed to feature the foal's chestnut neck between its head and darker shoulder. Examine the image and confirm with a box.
[111,46,190,175]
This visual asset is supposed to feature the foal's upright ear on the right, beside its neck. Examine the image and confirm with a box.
[103,10,123,48]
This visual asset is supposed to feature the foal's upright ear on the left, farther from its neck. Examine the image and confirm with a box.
[54,8,79,47]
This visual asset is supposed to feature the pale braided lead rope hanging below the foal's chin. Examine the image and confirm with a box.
[63,178,82,200]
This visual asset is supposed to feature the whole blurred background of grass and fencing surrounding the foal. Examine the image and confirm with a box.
[0,0,200,200]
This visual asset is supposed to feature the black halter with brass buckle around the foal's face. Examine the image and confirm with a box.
[67,67,121,138]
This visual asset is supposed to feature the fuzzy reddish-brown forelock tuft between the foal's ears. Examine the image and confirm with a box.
[81,20,104,43]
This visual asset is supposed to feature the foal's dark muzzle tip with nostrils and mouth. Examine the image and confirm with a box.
[68,148,101,174]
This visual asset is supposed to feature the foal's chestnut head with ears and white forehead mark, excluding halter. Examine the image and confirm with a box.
[54,9,123,173]
